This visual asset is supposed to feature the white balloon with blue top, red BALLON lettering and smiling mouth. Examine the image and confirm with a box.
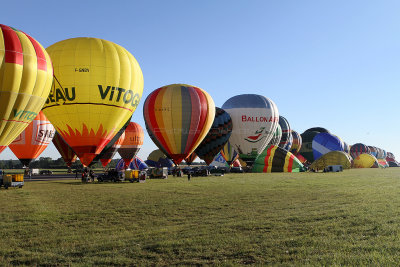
[222,94,279,166]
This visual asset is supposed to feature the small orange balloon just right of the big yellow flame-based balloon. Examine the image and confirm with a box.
[118,122,144,166]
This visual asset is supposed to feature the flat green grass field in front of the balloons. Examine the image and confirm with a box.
[0,168,400,266]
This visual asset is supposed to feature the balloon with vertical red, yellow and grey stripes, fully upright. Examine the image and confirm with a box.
[143,84,215,164]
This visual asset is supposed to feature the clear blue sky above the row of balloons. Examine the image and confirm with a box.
[0,0,400,159]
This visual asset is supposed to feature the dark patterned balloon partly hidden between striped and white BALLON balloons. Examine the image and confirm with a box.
[195,107,232,165]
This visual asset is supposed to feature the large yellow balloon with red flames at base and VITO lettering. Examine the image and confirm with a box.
[43,37,143,166]
